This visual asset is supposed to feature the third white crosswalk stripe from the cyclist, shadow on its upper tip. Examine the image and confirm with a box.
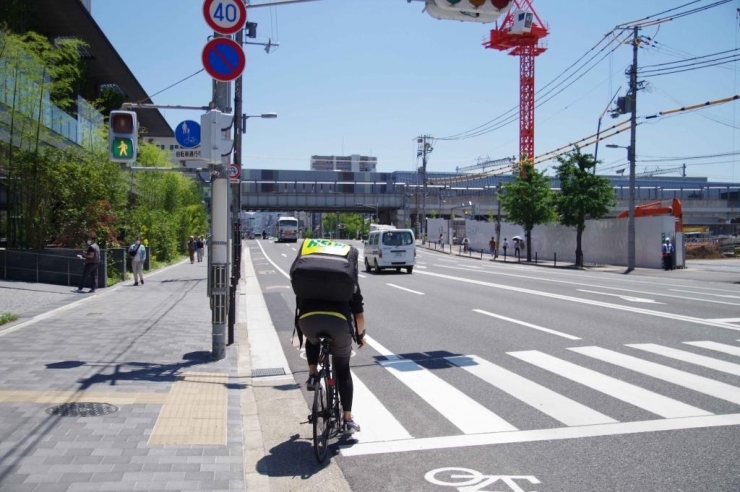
[445,355,618,426]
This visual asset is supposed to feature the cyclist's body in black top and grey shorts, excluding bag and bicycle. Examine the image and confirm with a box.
[296,278,365,434]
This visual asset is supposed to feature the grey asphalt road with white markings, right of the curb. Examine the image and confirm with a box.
[250,241,740,492]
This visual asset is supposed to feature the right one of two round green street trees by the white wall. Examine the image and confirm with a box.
[554,147,615,266]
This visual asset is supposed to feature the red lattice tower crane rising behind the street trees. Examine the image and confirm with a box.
[483,0,548,167]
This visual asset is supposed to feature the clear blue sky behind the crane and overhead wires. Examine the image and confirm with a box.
[92,0,740,182]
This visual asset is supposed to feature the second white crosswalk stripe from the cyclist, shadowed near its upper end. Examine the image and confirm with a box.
[365,335,516,434]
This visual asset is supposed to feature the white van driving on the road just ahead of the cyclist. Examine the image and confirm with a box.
[365,229,416,273]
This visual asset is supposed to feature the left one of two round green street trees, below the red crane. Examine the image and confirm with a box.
[500,161,556,261]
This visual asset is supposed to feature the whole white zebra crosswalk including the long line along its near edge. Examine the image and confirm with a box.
[341,337,740,456]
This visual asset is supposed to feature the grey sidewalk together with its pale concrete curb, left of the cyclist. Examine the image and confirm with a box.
[0,248,349,492]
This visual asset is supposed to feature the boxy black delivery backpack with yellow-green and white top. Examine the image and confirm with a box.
[290,239,359,302]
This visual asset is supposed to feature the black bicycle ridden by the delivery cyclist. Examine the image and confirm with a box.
[308,337,342,463]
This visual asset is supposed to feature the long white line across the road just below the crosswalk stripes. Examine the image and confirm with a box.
[339,413,740,456]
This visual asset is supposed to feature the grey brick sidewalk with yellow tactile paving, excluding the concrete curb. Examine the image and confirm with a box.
[0,262,245,492]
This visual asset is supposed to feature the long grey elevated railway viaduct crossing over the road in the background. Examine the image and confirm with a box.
[241,169,740,234]
